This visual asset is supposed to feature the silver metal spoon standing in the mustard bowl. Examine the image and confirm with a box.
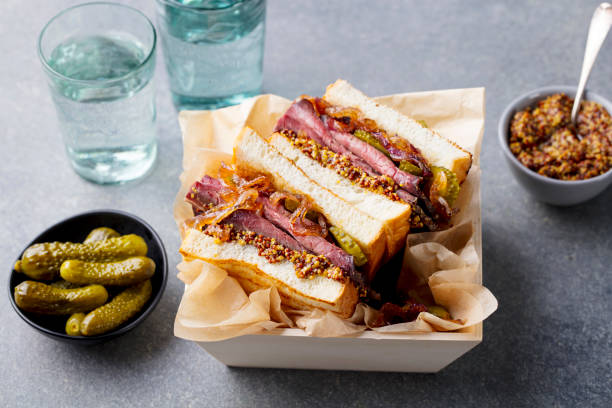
[572,3,612,132]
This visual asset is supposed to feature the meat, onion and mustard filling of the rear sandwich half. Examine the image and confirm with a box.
[275,97,459,230]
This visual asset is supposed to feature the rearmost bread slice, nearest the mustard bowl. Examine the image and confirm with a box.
[323,79,472,183]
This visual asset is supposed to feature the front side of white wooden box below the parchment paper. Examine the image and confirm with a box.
[198,323,482,373]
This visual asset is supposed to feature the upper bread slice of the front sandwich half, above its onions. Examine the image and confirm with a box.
[234,127,386,280]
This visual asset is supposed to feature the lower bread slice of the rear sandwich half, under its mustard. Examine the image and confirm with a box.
[269,133,411,258]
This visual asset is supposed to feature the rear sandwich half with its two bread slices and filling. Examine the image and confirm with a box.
[269,80,472,233]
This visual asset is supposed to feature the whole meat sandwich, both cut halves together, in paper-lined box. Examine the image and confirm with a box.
[180,80,471,317]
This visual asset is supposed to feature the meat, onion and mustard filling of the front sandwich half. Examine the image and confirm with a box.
[186,166,367,287]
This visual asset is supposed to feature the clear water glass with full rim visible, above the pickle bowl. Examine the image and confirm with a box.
[38,3,157,184]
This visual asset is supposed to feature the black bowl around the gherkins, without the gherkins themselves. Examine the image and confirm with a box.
[9,210,168,345]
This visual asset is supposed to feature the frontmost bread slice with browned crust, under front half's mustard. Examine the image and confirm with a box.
[180,229,358,317]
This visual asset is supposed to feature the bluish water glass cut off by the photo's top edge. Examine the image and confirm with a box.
[157,0,266,110]
